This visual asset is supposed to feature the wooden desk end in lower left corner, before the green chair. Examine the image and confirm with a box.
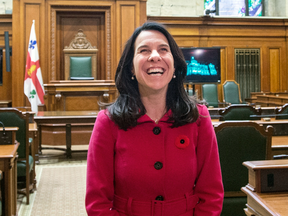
[0,140,19,215]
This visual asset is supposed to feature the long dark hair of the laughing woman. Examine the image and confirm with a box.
[108,22,199,130]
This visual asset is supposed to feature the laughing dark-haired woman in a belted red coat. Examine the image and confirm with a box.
[86,22,223,216]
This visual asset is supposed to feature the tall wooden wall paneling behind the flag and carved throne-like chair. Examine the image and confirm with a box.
[11,0,146,106]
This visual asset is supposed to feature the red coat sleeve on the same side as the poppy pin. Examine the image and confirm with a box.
[194,105,224,216]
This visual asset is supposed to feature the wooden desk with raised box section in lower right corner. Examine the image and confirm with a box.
[241,160,288,216]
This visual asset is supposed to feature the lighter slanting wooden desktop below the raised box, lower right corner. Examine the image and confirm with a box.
[241,183,288,216]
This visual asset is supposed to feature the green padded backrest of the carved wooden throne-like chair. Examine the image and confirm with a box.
[70,56,94,80]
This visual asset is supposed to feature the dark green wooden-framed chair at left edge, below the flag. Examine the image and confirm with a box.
[0,108,36,204]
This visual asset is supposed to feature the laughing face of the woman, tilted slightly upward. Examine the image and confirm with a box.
[132,30,175,94]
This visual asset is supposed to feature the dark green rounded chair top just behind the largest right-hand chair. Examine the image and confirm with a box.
[219,104,262,121]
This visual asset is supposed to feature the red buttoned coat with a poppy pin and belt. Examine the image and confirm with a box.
[86,105,224,216]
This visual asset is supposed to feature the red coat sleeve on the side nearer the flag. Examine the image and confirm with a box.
[85,111,119,216]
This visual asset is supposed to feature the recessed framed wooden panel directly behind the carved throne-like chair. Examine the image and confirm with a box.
[50,6,111,80]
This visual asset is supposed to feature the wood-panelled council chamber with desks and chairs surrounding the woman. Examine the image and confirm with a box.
[0,0,288,216]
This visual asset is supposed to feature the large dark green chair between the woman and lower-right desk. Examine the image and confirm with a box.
[214,121,273,216]
